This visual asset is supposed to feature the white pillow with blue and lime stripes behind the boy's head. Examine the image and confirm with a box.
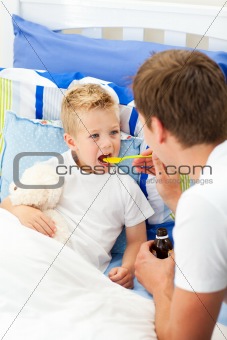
[0,68,143,160]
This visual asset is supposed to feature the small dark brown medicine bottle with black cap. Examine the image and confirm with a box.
[150,228,173,259]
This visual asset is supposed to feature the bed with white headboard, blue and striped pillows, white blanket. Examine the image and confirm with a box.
[0,0,227,340]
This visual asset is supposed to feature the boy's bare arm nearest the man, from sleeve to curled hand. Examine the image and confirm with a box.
[109,222,147,288]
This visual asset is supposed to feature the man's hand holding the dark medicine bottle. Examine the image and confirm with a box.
[135,241,175,295]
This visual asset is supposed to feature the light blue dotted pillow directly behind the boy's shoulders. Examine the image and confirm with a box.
[1,111,142,199]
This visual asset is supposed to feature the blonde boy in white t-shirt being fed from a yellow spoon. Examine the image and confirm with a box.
[2,84,154,288]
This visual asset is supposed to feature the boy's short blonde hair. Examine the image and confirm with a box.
[61,84,119,136]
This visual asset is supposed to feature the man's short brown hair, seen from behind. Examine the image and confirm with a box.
[133,50,227,147]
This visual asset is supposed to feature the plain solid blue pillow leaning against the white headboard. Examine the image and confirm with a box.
[13,15,227,86]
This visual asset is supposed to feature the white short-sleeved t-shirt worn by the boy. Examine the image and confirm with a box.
[47,150,154,271]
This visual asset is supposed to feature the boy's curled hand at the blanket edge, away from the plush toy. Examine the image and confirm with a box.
[108,267,134,289]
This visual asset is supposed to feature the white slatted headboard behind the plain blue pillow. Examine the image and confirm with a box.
[0,0,227,67]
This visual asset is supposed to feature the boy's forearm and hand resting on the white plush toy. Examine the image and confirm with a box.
[0,197,56,237]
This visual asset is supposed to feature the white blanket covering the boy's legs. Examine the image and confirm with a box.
[0,209,156,340]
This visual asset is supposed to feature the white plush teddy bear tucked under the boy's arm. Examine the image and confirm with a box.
[9,163,71,245]
